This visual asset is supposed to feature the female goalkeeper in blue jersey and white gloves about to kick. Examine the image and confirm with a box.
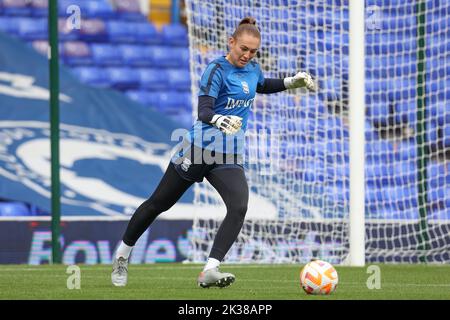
[111,17,315,288]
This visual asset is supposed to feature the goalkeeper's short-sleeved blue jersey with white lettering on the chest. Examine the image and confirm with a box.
[188,57,264,154]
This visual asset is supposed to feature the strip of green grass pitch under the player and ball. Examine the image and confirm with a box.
[0,263,450,300]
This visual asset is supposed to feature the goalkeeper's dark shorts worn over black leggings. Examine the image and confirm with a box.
[172,144,244,182]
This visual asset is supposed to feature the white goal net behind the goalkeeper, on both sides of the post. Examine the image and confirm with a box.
[186,0,450,264]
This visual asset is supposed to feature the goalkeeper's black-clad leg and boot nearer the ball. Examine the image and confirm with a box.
[197,166,249,287]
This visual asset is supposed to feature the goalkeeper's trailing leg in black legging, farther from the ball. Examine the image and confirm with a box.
[111,163,194,286]
